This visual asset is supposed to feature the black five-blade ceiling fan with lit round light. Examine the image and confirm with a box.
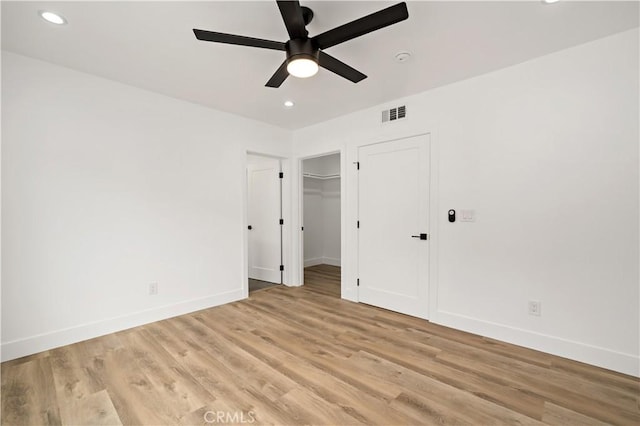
[193,0,409,87]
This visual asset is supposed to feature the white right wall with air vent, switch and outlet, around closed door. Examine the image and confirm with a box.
[293,29,640,375]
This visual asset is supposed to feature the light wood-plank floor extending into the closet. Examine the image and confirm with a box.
[2,265,640,425]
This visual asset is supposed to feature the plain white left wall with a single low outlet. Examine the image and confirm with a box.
[2,52,291,360]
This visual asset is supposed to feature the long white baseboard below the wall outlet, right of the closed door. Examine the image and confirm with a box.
[431,311,640,377]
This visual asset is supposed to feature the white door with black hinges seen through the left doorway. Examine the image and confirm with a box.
[247,159,282,283]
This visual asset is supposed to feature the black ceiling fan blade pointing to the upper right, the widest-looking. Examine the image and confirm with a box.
[311,2,409,49]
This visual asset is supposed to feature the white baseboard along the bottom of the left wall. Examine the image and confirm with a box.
[2,289,244,361]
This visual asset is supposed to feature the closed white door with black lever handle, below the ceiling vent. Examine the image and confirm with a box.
[358,135,430,318]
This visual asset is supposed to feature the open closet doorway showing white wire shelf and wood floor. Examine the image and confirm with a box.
[302,153,341,297]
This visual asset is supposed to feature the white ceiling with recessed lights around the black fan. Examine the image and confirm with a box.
[2,0,639,129]
